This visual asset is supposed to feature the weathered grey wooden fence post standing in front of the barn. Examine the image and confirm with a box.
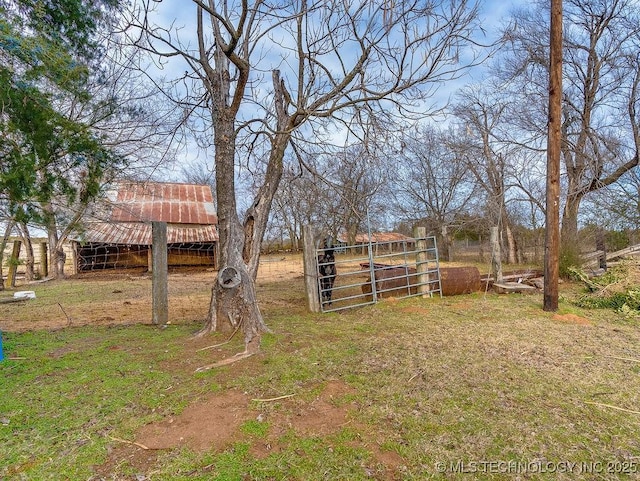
[151,222,169,325]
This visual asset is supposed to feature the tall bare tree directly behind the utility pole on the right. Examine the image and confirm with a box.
[502,0,640,246]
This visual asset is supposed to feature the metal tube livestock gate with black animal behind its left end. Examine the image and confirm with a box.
[308,230,442,312]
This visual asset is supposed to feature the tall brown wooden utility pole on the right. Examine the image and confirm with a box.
[543,0,562,311]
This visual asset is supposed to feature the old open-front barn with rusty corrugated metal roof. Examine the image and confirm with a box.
[73,182,218,270]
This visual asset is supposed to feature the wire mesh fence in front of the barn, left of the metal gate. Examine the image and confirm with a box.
[0,253,304,332]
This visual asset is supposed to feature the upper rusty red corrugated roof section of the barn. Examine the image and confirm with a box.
[110,182,218,224]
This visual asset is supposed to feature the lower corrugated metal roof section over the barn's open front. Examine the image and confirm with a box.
[76,222,218,245]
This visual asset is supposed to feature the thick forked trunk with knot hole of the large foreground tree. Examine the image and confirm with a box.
[201,71,295,355]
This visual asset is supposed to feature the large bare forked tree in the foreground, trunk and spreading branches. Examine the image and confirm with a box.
[130,0,477,355]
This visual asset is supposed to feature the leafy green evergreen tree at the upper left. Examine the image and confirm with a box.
[0,0,122,276]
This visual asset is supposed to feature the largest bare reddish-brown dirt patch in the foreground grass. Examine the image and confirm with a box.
[94,380,404,479]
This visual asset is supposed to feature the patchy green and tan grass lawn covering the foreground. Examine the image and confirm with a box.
[0,270,640,481]
